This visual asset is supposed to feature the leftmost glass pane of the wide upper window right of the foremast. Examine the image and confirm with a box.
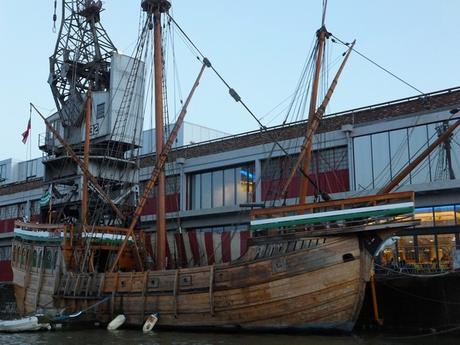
[353,136,373,190]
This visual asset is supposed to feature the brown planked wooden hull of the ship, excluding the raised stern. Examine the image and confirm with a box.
[28,235,370,332]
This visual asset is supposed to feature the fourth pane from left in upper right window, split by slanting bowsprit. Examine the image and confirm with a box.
[409,126,430,183]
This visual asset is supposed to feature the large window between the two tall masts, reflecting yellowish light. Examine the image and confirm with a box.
[188,163,256,210]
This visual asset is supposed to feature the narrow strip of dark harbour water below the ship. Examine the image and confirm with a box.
[0,329,459,345]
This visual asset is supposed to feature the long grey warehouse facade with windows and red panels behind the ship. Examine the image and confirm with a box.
[0,88,460,281]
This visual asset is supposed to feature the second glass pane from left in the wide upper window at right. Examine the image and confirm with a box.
[372,132,390,188]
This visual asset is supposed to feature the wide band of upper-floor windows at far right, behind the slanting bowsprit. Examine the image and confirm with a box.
[353,122,460,190]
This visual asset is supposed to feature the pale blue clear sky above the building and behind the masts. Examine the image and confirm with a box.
[0,0,460,160]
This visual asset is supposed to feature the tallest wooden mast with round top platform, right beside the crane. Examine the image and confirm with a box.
[142,0,171,270]
